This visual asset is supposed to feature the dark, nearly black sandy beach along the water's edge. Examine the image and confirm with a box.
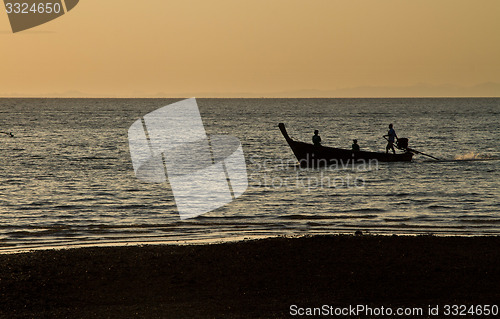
[0,236,500,318]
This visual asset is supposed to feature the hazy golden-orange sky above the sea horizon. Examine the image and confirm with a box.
[0,0,500,97]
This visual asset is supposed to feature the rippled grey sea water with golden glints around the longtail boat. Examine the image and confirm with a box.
[0,98,500,252]
